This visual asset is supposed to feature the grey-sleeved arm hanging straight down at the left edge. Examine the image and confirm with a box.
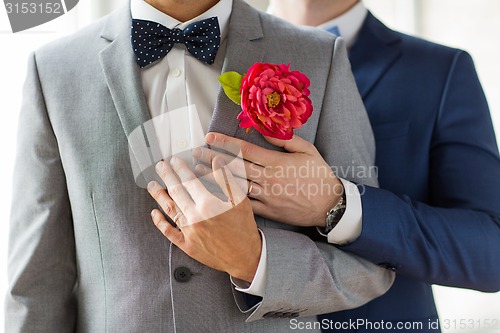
[5,56,76,333]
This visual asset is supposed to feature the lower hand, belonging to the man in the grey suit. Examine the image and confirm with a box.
[148,157,262,283]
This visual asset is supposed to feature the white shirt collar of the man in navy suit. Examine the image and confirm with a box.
[318,1,368,48]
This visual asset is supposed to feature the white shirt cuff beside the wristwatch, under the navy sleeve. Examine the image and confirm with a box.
[328,179,363,245]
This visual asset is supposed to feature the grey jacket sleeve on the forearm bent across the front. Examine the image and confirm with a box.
[234,228,394,322]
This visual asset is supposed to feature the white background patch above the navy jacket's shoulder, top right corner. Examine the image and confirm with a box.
[364,0,500,147]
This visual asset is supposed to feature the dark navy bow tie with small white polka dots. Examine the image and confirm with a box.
[130,17,220,68]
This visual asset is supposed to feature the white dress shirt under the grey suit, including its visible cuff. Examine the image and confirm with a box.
[130,0,267,296]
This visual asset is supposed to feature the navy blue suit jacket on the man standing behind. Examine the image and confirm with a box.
[320,14,500,332]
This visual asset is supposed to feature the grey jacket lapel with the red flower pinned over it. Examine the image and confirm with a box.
[209,0,269,147]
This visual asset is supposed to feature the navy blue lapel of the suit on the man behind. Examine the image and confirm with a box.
[349,13,401,99]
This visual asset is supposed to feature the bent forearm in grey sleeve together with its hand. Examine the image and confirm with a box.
[148,156,394,321]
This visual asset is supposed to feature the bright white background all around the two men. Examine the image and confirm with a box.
[0,0,500,333]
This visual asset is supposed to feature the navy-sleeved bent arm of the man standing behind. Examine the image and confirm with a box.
[343,52,500,291]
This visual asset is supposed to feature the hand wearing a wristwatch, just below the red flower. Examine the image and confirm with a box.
[193,133,344,227]
